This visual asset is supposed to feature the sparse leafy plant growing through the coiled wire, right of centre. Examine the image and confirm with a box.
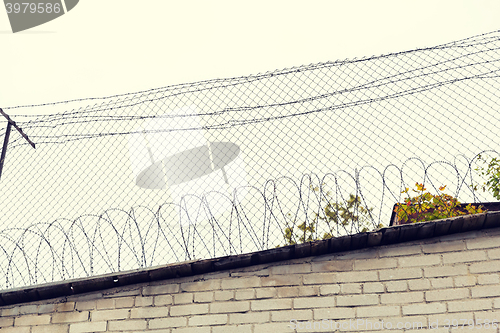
[283,187,382,245]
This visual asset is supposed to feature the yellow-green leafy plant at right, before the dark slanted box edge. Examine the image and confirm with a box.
[394,183,485,223]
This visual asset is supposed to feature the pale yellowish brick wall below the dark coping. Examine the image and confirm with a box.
[0,228,500,333]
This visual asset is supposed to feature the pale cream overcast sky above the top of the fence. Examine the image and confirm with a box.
[0,0,500,114]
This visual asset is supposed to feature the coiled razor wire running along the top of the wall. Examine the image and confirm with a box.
[0,151,500,288]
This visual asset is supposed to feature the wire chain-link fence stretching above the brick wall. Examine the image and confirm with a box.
[0,31,500,288]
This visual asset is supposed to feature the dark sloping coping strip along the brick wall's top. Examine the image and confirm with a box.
[0,211,500,306]
